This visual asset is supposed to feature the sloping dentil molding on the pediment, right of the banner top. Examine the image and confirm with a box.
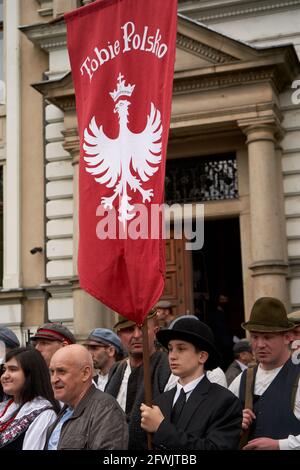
[176,33,236,64]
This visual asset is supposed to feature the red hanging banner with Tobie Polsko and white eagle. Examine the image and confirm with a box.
[65,0,177,324]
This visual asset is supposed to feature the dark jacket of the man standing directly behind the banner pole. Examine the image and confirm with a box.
[105,351,171,450]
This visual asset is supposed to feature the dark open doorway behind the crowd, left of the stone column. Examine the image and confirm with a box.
[192,218,245,368]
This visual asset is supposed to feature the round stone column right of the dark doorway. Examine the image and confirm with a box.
[244,123,289,308]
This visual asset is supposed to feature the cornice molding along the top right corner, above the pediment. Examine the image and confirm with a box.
[178,0,300,23]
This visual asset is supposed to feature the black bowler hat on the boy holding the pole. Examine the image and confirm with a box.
[156,315,221,370]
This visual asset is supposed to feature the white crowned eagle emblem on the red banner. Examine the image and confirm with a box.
[83,73,163,226]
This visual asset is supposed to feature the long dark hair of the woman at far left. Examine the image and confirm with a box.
[6,347,60,412]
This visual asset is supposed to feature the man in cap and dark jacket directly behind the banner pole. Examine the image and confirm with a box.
[105,309,170,449]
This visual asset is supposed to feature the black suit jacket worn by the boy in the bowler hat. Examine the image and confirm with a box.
[153,377,242,451]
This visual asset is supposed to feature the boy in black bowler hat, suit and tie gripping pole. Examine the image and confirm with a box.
[141,317,242,451]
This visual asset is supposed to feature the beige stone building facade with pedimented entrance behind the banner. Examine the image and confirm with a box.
[0,0,300,341]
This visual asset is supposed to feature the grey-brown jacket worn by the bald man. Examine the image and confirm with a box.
[45,385,128,450]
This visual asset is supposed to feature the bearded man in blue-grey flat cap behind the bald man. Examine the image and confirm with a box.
[83,328,124,391]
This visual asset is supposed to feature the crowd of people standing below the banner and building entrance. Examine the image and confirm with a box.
[0,297,300,451]
